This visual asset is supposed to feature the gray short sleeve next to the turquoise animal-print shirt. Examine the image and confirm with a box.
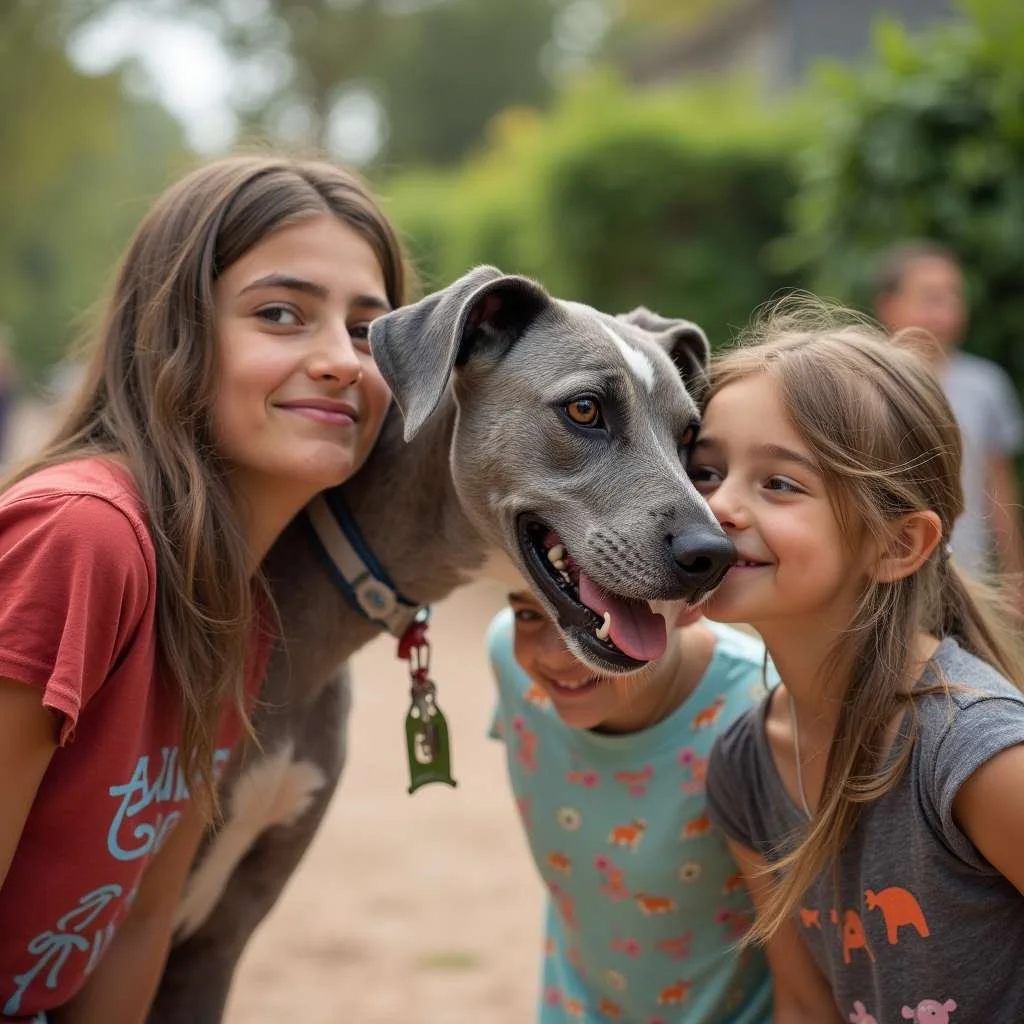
[707,706,761,850]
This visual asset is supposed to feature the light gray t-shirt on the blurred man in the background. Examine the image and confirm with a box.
[942,352,1024,575]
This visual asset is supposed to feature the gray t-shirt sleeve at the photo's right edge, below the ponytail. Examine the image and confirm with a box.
[925,696,1024,868]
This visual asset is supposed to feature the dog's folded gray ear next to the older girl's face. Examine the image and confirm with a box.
[370,266,551,440]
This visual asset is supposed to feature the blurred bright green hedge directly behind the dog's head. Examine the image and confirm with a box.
[382,78,805,343]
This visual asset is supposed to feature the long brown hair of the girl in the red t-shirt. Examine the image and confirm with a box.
[7,157,406,818]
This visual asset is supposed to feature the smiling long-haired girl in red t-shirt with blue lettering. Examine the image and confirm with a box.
[0,158,404,1024]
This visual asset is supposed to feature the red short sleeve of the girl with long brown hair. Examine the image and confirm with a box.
[0,494,150,743]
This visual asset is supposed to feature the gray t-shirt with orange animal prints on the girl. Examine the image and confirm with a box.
[708,639,1024,1024]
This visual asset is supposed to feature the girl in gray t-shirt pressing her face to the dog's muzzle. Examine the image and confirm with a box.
[689,306,1024,1024]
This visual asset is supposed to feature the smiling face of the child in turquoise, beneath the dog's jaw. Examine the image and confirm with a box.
[509,591,700,732]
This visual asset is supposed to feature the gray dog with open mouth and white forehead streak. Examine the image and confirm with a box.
[151,267,735,1024]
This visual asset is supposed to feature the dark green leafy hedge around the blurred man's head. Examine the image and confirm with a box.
[776,0,1024,384]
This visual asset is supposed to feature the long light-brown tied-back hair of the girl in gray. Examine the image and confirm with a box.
[708,299,1024,941]
